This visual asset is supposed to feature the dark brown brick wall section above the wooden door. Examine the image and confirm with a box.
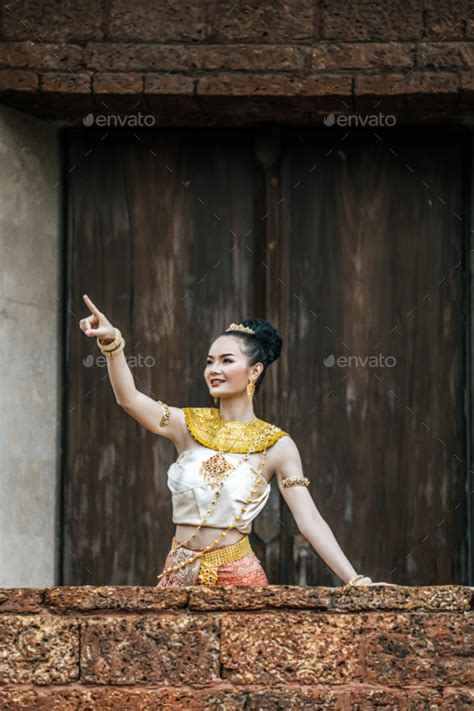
[0,0,474,125]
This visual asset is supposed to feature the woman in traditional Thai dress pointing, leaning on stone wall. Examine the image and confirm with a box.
[80,294,389,587]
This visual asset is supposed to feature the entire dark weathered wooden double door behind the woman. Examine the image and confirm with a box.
[62,128,469,585]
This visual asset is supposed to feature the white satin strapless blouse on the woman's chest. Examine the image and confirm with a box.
[167,447,271,534]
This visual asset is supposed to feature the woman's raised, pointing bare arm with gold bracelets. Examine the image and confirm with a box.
[79,294,186,444]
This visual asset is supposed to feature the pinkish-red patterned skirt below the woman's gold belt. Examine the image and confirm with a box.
[156,537,269,588]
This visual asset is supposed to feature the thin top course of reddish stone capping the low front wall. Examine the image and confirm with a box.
[12,585,474,614]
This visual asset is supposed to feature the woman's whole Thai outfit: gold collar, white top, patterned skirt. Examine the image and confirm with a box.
[158,408,287,587]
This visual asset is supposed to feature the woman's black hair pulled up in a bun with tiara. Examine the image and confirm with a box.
[221,318,283,395]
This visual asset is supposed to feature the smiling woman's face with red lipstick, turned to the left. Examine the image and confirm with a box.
[204,336,263,397]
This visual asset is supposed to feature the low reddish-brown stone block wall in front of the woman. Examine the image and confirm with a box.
[0,585,474,711]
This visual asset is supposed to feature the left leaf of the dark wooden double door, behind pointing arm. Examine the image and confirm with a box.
[63,130,260,585]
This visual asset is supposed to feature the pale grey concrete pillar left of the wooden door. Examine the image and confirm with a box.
[0,106,62,587]
